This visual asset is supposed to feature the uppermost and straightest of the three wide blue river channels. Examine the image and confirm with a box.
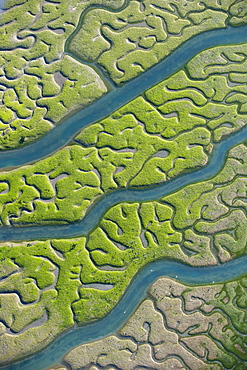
[0,26,247,168]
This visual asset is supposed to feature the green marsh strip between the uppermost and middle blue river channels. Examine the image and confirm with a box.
[0,44,247,225]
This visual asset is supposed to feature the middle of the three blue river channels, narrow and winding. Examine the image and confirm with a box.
[0,121,247,241]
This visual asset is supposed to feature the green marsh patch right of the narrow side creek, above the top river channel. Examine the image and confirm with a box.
[69,0,247,84]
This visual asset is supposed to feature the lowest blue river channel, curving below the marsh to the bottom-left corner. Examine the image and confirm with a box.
[2,256,247,370]
